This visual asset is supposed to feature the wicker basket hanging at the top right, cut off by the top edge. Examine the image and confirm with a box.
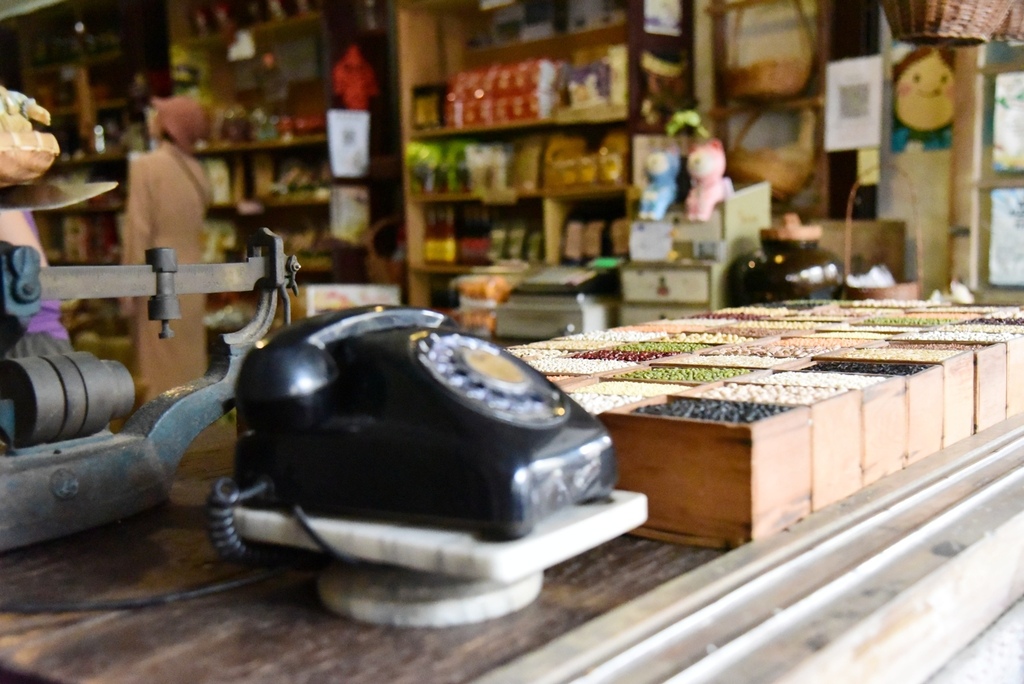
[882,0,1015,45]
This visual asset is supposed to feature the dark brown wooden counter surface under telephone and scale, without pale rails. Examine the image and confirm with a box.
[0,434,722,684]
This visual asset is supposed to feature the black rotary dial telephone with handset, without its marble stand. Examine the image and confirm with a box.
[236,306,616,539]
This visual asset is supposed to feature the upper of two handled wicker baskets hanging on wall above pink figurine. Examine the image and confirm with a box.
[723,0,814,100]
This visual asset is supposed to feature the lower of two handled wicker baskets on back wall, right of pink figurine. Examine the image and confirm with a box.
[726,110,817,201]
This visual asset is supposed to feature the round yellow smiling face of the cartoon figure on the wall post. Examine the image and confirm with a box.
[894,47,953,132]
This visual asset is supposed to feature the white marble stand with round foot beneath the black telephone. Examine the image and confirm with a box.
[236,491,647,627]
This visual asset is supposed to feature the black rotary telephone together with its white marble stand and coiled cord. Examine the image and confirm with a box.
[210,306,646,626]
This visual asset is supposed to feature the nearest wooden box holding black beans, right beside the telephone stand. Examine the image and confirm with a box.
[600,397,811,547]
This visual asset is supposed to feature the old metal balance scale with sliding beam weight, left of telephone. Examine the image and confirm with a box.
[0,183,298,551]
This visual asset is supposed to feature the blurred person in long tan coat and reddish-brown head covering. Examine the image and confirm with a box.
[122,96,210,401]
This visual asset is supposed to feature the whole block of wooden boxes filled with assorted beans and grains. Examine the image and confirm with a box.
[514,301,1024,546]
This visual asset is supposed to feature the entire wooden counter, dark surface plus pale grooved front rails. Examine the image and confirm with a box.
[0,416,1024,684]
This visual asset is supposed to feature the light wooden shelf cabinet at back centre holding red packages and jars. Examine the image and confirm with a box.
[397,0,692,306]
